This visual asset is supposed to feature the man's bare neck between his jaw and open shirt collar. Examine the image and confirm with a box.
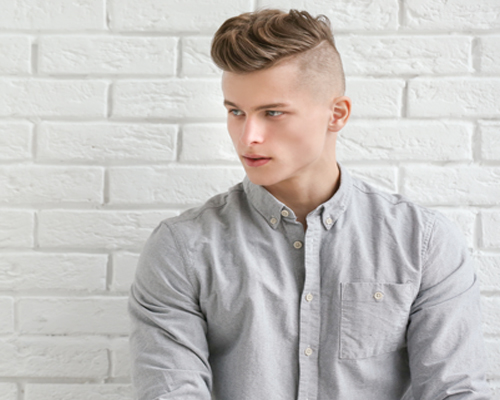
[265,162,340,227]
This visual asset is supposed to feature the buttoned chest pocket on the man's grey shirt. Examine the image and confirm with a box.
[340,282,413,359]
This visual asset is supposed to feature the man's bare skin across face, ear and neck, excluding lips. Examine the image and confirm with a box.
[222,59,351,229]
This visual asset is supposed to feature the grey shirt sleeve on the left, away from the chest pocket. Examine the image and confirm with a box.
[129,223,212,400]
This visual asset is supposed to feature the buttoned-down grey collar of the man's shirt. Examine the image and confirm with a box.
[243,162,352,230]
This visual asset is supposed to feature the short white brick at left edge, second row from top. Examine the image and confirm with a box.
[0,36,31,74]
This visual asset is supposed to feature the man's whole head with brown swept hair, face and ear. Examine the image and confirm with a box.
[212,10,350,190]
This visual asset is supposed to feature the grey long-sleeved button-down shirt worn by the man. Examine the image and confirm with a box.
[130,166,489,400]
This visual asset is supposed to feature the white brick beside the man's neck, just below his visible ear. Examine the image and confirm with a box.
[337,120,474,161]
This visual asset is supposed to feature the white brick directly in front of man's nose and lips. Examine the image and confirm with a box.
[180,124,239,163]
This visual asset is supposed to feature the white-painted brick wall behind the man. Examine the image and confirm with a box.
[0,0,500,400]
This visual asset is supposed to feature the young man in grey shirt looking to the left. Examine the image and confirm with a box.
[130,10,488,400]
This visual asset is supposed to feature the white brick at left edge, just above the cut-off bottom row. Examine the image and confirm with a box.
[0,337,109,379]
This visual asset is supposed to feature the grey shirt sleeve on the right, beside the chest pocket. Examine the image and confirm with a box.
[407,213,490,400]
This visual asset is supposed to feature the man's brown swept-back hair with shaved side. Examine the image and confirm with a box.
[210,9,345,94]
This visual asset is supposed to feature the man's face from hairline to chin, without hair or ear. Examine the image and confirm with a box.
[222,62,336,187]
